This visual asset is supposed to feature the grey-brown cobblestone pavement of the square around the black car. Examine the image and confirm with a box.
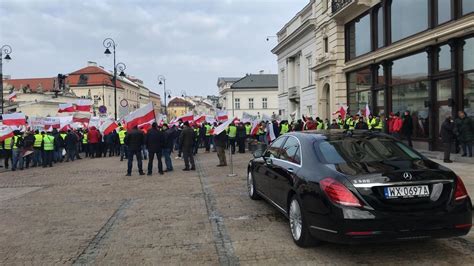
[0,153,474,265]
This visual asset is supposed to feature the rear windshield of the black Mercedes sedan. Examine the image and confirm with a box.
[315,137,421,164]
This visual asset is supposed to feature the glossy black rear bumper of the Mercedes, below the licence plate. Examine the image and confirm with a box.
[307,203,472,244]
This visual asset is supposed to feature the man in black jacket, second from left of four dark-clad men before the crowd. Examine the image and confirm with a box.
[145,123,165,175]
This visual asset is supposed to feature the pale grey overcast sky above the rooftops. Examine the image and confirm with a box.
[0,0,309,95]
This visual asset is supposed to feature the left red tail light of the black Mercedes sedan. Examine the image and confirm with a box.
[319,177,362,207]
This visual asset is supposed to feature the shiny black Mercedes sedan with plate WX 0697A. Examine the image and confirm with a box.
[247,130,472,247]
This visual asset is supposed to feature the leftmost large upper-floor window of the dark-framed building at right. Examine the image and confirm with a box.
[348,14,372,59]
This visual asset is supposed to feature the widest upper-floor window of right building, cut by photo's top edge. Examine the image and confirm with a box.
[391,0,428,42]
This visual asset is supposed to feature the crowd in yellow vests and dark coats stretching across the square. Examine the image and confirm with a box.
[0,111,474,176]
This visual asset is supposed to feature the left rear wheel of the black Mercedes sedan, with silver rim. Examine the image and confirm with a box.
[288,195,318,247]
